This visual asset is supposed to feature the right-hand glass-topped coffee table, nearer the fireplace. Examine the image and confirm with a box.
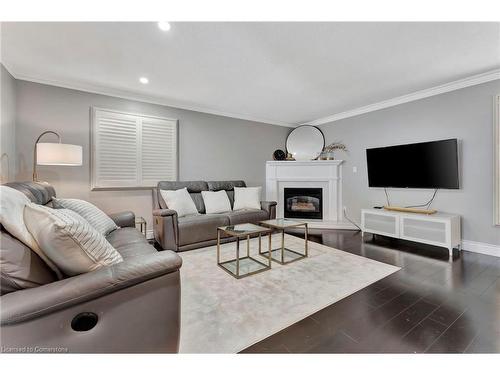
[259,219,309,264]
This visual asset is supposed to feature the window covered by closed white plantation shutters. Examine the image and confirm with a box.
[91,108,178,189]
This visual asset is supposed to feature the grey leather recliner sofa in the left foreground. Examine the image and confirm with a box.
[0,182,182,353]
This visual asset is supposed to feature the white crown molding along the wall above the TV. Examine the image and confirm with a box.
[304,69,500,125]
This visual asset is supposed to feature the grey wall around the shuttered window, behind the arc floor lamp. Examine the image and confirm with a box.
[16,81,290,229]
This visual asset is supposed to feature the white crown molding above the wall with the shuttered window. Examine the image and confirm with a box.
[3,67,297,128]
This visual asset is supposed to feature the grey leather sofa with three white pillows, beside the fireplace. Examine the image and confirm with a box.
[153,181,276,251]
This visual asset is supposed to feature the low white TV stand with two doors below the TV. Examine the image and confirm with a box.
[361,209,462,260]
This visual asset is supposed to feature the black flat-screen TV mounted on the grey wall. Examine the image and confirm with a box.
[366,139,459,189]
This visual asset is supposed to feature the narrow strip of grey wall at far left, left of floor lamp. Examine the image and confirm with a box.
[0,64,16,182]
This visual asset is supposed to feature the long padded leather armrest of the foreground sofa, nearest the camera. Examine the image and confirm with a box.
[1,251,182,325]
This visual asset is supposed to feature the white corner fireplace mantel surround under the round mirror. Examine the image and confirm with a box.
[266,160,355,229]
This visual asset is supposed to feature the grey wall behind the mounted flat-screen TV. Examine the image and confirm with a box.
[321,81,500,245]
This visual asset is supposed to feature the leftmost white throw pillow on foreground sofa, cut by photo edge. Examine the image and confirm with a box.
[0,186,62,279]
